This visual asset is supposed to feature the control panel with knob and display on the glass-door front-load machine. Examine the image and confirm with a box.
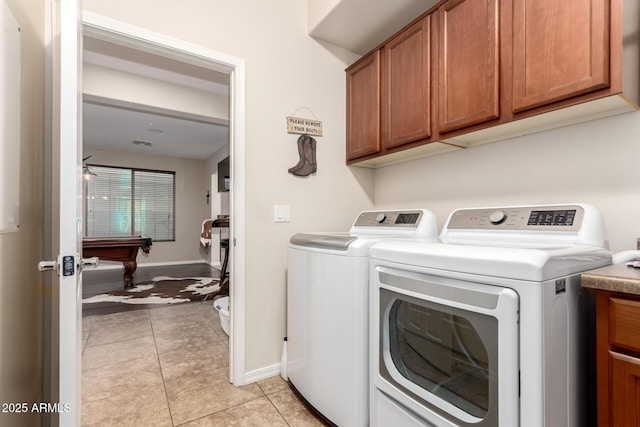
[447,205,584,231]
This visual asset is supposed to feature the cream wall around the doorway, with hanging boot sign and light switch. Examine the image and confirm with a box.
[83,0,373,372]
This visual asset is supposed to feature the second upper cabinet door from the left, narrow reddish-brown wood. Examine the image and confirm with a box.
[382,16,431,148]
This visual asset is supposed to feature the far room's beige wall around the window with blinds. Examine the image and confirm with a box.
[83,149,209,266]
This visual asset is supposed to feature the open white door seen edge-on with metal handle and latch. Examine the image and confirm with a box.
[39,0,89,426]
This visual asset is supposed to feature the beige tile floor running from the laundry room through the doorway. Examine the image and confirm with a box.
[82,302,325,427]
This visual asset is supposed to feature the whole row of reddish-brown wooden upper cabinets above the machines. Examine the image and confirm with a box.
[346,0,640,167]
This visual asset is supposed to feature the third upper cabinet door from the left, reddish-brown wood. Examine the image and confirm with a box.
[438,0,500,133]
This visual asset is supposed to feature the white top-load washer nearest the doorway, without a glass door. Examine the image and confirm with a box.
[287,209,437,427]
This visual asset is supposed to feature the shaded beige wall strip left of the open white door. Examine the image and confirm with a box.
[0,0,44,426]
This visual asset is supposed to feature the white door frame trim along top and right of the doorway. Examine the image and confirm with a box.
[82,11,247,386]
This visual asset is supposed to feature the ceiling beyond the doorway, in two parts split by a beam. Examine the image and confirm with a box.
[83,37,229,160]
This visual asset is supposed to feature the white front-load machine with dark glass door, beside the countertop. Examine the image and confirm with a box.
[370,204,611,427]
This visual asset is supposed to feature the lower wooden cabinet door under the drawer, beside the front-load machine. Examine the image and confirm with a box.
[609,351,640,427]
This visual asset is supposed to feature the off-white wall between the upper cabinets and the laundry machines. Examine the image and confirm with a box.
[375,112,640,252]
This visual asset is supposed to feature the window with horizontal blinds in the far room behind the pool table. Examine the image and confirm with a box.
[85,165,175,242]
